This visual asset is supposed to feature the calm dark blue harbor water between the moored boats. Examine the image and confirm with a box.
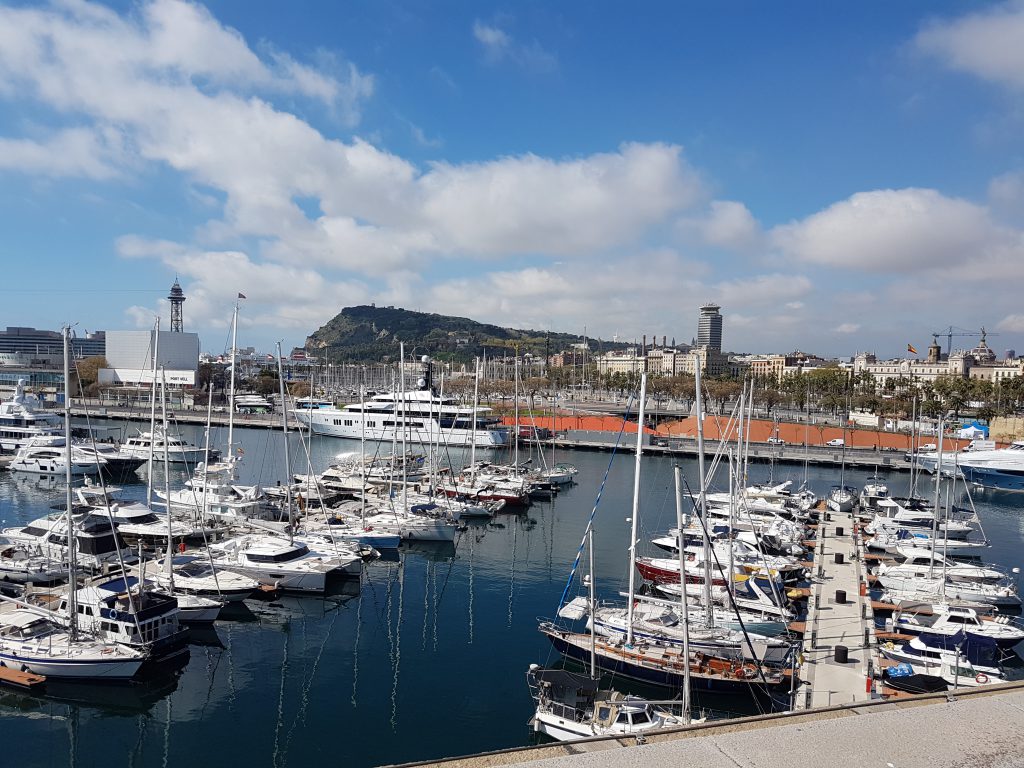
[0,421,1024,768]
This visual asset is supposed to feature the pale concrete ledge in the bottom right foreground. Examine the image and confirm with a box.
[397,682,1024,768]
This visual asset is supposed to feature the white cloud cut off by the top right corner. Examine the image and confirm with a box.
[914,2,1024,89]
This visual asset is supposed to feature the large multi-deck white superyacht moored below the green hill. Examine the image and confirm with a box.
[293,362,510,447]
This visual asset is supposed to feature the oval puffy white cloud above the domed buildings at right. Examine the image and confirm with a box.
[770,188,1012,274]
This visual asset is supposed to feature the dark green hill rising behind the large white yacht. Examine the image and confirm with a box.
[306,306,626,362]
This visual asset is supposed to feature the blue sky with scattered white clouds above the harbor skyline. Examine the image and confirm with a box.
[0,0,1024,356]
